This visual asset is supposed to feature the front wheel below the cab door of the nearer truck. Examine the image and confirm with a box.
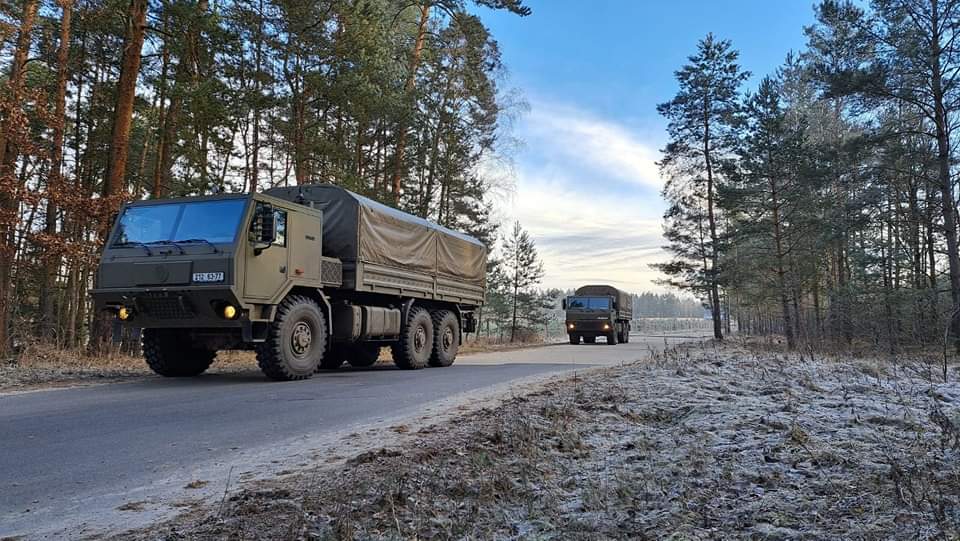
[257,295,327,381]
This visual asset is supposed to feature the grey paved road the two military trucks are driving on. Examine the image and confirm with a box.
[0,336,700,538]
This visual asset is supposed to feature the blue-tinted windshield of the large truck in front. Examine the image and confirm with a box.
[113,199,247,246]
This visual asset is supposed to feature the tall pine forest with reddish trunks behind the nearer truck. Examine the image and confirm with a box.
[0,0,530,353]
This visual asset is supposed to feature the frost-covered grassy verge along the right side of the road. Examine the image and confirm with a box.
[129,344,960,539]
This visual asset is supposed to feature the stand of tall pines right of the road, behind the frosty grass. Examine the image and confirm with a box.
[658,0,960,352]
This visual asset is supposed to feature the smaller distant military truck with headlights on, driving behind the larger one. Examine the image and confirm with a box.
[563,285,633,346]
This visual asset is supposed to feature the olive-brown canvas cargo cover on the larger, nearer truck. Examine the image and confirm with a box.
[266,184,487,286]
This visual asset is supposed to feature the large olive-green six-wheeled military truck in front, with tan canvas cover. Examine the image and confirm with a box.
[91,185,486,380]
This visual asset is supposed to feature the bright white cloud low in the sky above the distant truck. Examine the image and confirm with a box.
[484,101,668,292]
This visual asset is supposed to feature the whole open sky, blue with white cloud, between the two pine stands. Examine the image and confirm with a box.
[481,0,813,292]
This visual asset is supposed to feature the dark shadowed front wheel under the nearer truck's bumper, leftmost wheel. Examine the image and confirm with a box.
[141,329,217,378]
